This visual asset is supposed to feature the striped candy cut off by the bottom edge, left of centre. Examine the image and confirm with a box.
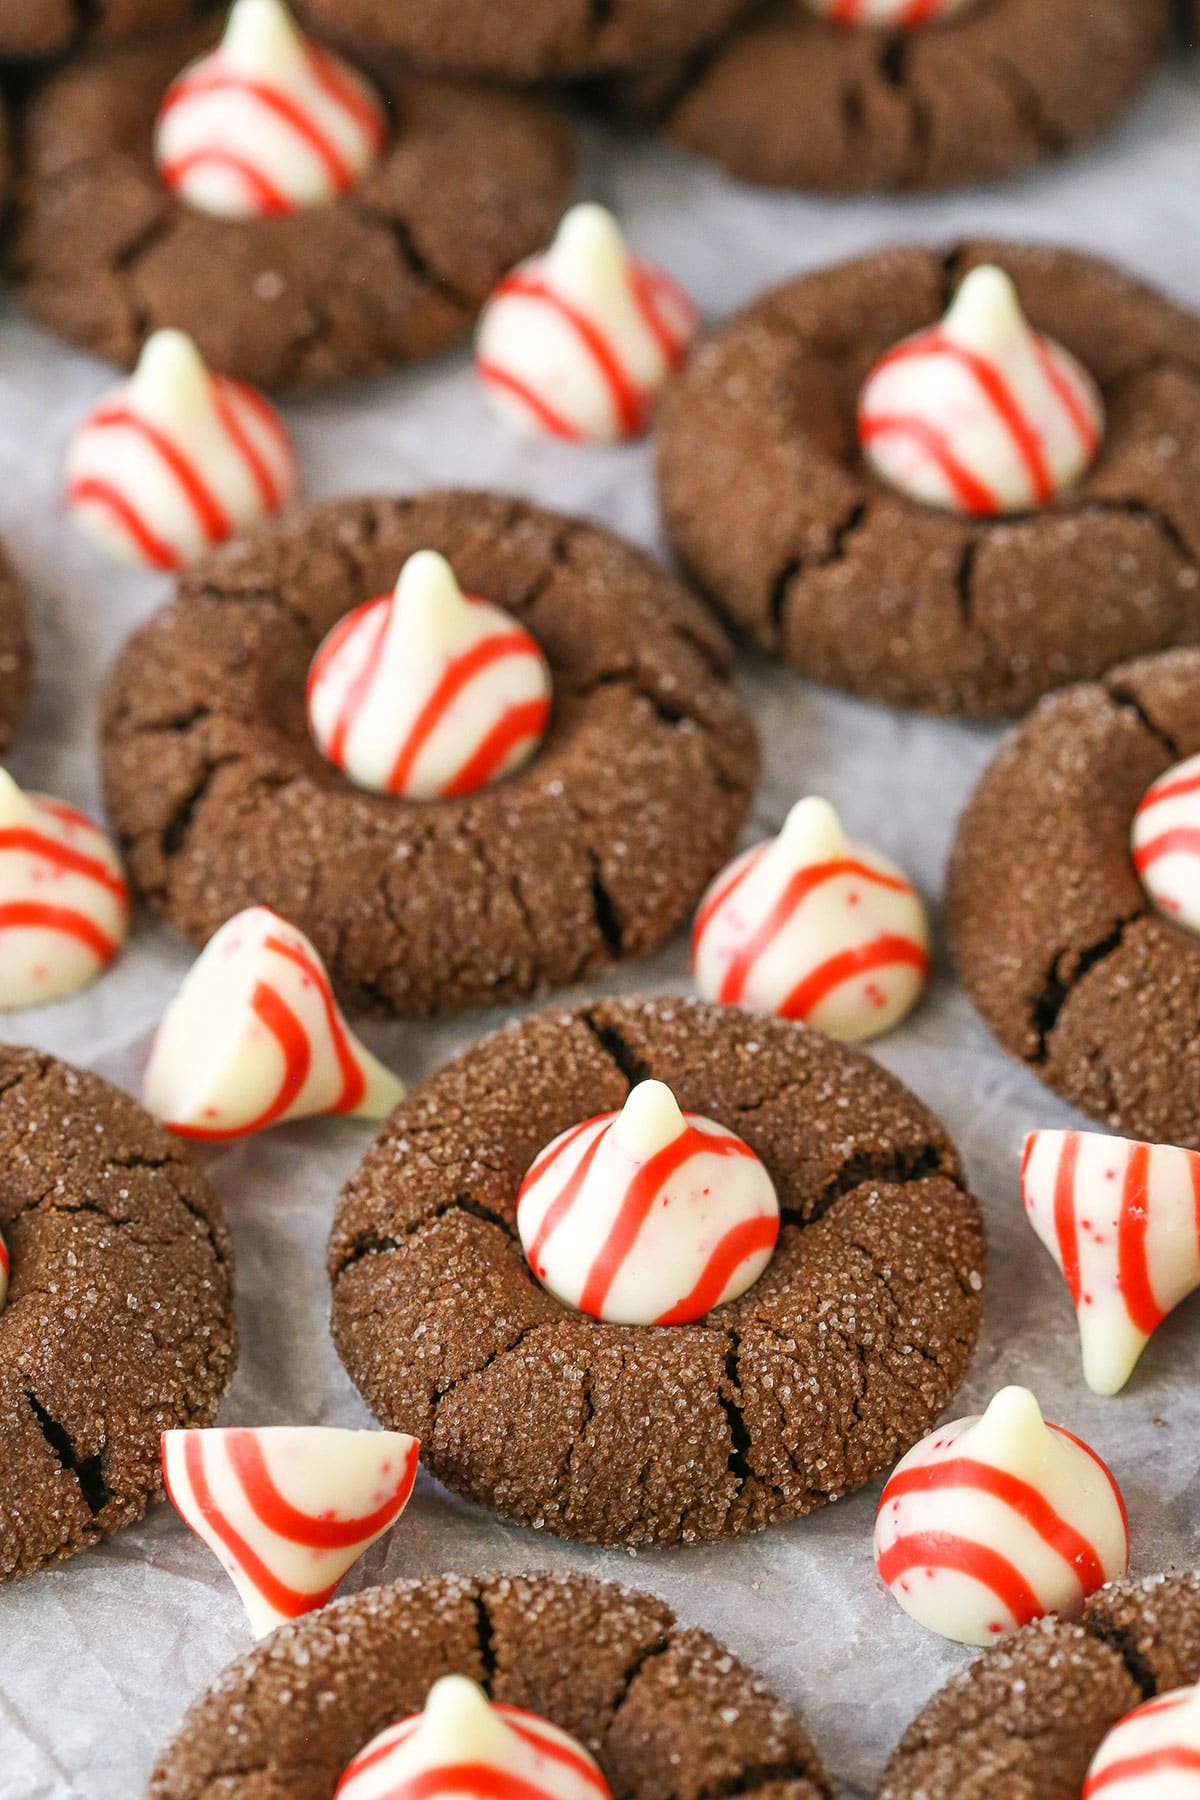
[336,1676,610,1800]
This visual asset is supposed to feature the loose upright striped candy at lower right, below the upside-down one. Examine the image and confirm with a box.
[874,1388,1130,1643]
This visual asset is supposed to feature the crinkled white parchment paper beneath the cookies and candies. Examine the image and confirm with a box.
[0,59,1200,1800]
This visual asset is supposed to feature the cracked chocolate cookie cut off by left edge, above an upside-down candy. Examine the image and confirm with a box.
[0,1049,236,1580]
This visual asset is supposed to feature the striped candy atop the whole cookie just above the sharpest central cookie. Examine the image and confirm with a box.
[308,551,551,799]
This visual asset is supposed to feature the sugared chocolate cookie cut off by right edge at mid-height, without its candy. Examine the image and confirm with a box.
[946,650,1200,1148]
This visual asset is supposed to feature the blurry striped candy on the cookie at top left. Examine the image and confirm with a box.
[155,0,387,220]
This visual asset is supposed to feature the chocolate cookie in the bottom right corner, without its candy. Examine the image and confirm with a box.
[880,1573,1200,1800]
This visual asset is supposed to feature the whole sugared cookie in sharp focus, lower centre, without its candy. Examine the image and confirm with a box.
[329,1001,984,1544]
